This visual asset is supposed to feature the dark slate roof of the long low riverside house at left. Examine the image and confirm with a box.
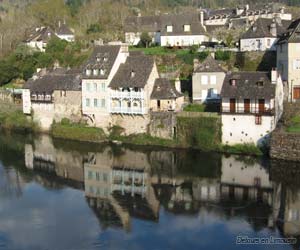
[23,68,81,94]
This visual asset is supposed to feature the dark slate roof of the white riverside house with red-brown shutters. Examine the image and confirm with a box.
[221,72,276,99]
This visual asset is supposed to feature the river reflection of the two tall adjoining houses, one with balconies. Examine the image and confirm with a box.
[84,147,159,230]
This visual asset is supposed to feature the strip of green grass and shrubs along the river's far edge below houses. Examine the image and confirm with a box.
[0,110,263,156]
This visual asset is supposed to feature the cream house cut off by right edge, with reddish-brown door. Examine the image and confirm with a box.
[276,19,300,101]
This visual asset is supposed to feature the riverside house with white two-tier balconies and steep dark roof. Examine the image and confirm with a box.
[109,52,159,134]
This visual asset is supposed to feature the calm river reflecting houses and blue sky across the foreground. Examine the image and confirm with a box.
[0,133,300,250]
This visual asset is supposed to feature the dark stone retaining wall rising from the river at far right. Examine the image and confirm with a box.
[270,129,300,161]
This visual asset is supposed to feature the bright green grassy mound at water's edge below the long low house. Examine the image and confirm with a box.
[51,119,106,142]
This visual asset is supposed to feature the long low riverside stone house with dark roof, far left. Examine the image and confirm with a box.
[23,68,81,130]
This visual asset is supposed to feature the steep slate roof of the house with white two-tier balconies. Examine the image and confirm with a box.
[109,54,154,88]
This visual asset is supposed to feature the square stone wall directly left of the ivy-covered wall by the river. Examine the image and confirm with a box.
[149,112,176,139]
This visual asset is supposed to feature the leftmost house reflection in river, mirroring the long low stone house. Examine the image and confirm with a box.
[25,135,83,188]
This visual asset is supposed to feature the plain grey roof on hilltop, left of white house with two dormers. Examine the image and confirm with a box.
[124,16,161,32]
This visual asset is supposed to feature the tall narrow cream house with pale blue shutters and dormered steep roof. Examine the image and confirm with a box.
[82,45,129,129]
